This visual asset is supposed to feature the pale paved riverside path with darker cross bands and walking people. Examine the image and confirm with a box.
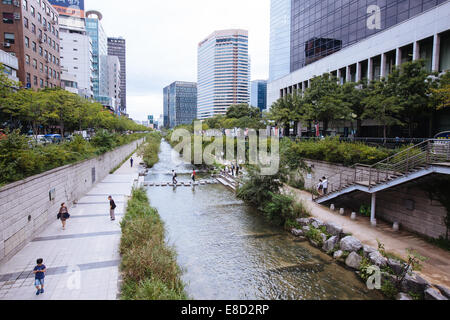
[0,156,141,300]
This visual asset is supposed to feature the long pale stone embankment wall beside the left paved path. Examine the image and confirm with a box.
[0,139,144,262]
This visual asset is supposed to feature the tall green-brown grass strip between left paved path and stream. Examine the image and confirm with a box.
[120,188,187,300]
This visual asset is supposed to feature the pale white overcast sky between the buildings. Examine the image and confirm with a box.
[85,0,270,120]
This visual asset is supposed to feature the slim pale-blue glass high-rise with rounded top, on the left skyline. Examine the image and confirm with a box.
[86,10,107,106]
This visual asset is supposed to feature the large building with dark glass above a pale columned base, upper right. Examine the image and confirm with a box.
[268,0,450,105]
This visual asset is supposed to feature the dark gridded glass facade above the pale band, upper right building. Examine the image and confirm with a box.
[290,0,447,72]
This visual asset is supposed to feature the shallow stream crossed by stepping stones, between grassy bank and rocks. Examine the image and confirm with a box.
[145,140,383,300]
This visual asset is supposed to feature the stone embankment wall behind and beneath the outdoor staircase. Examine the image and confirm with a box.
[304,160,447,238]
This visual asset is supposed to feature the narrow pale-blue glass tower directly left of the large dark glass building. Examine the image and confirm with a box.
[269,0,292,81]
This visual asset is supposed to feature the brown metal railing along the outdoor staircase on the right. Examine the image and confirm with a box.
[313,139,450,200]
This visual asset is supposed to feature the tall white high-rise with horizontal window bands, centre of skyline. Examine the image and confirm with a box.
[197,29,250,119]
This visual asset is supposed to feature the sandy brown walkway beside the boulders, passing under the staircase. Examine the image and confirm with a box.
[287,187,450,288]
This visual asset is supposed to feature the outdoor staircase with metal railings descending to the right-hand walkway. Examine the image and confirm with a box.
[313,139,450,203]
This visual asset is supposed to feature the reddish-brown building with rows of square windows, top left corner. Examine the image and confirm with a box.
[0,0,61,89]
